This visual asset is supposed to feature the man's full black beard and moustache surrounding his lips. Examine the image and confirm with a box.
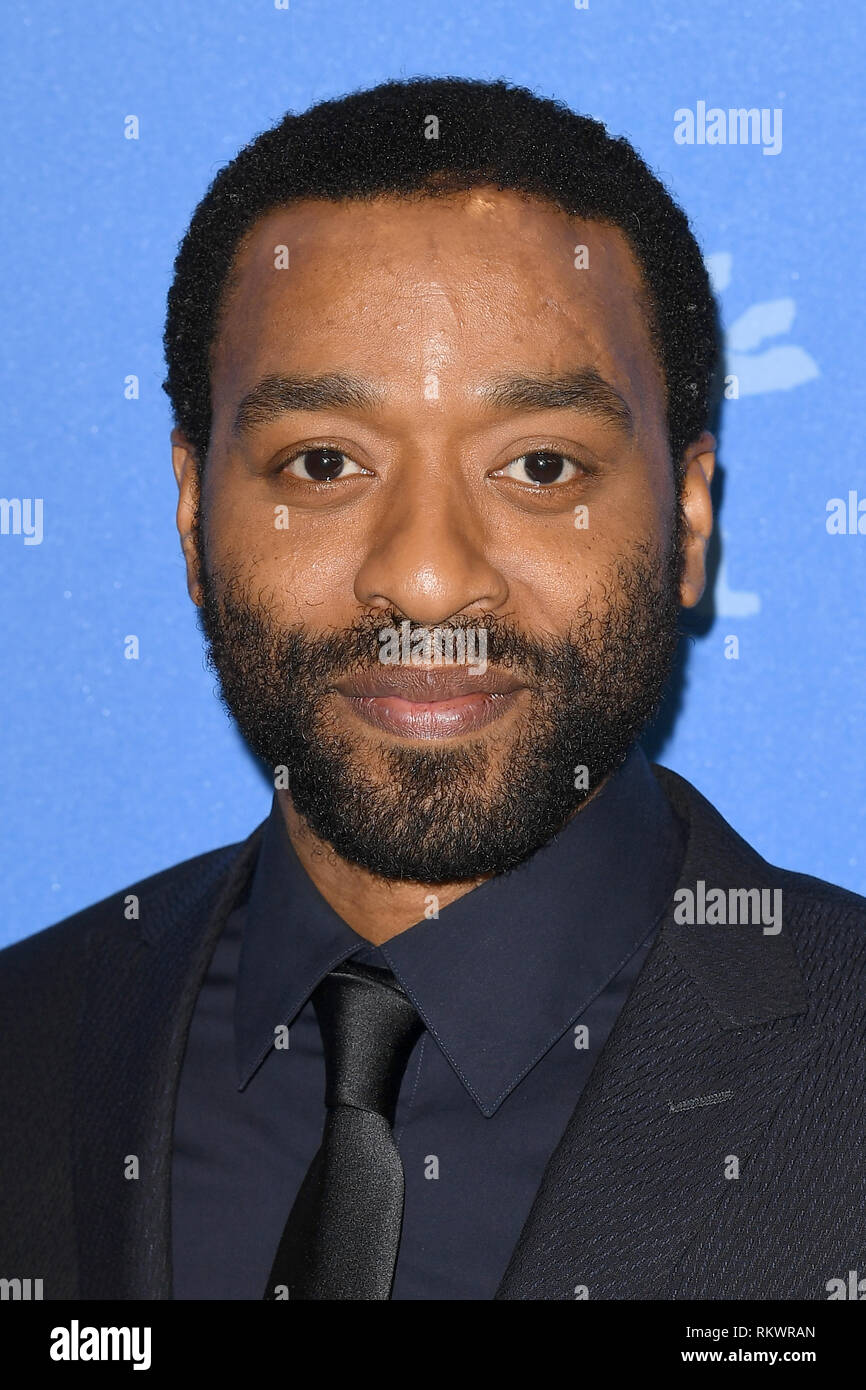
[195,517,683,884]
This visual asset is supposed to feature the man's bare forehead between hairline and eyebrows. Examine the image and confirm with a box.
[211,188,664,413]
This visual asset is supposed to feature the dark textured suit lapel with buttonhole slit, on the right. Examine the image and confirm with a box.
[496,769,816,1300]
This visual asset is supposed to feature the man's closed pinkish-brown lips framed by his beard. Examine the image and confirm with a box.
[335,667,527,739]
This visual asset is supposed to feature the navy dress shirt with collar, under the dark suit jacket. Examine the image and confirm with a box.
[172,744,685,1300]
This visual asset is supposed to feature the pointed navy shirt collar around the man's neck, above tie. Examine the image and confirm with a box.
[235,744,684,1115]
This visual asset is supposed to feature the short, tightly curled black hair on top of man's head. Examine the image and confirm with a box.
[163,78,720,487]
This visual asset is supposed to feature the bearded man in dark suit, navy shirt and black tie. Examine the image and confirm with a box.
[0,79,866,1301]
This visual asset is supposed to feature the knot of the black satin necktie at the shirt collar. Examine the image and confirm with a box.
[313,960,424,1125]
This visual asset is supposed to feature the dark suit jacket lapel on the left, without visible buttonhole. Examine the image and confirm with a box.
[72,826,263,1298]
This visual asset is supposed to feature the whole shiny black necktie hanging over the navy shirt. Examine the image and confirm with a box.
[264,960,424,1300]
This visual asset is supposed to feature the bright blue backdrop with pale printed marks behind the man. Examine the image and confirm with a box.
[0,0,866,944]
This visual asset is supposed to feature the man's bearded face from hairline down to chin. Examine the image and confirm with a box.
[175,188,712,883]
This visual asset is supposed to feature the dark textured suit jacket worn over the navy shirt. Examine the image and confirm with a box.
[0,766,866,1301]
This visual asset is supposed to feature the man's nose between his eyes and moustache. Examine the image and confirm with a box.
[354,470,509,627]
